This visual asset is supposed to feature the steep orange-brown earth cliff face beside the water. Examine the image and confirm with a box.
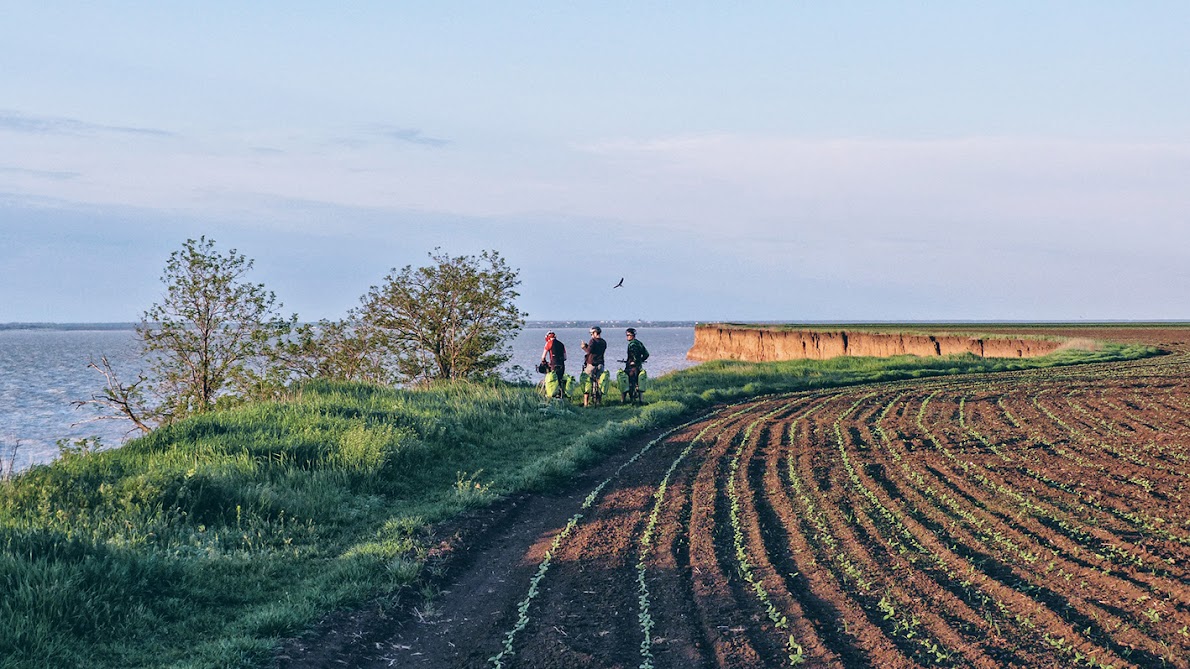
[685,325,1061,362]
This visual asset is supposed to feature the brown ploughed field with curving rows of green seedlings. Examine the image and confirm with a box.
[276,330,1190,668]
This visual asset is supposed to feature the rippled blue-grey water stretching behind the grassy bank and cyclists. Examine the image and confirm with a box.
[0,324,695,470]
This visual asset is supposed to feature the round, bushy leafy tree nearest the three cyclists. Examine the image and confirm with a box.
[356,249,527,382]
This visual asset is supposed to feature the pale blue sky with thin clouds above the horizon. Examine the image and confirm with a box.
[0,0,1190,323]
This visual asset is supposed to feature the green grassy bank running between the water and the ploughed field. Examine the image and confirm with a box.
[0,346,1152,667]
